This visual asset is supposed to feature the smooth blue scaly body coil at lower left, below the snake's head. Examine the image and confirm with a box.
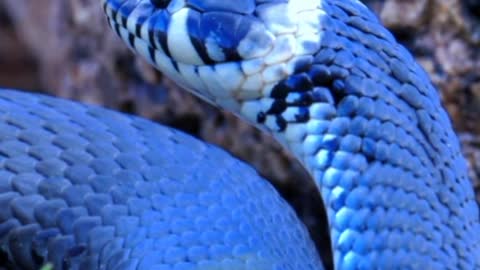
[0,89,323,270]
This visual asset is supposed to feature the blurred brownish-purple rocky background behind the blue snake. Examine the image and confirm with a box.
[0,0,480,268]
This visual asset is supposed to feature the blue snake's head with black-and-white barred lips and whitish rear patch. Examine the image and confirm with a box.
[103,0,324,120]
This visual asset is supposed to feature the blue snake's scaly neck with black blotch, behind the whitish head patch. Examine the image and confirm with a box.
[207,1,480,269]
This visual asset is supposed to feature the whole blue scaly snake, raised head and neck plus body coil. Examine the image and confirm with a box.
[0,0,480,270]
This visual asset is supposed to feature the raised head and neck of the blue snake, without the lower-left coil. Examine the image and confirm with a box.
[103,0,480,270]
